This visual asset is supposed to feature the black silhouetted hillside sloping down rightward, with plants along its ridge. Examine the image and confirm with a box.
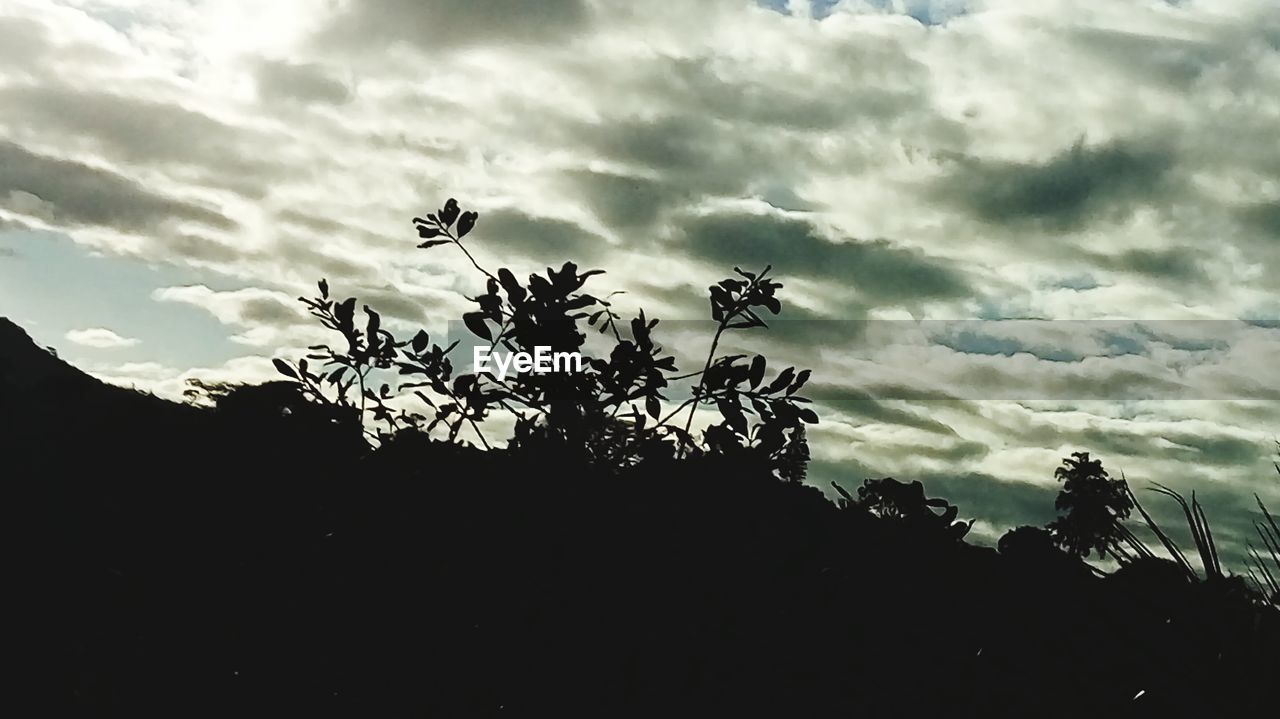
[0,199,1280,718]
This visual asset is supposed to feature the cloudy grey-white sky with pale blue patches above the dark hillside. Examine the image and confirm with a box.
[0,0,1280,551]
